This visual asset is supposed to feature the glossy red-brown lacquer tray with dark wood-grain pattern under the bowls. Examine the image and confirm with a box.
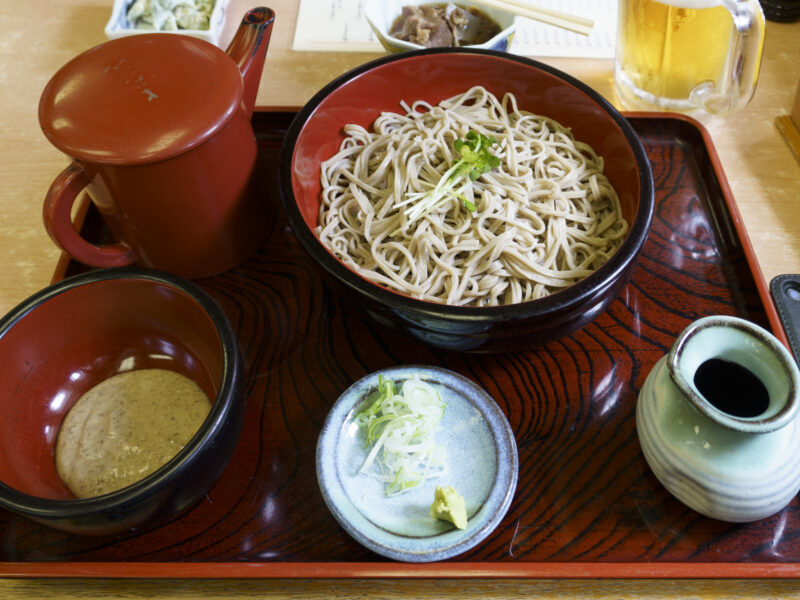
[0,111,800,577]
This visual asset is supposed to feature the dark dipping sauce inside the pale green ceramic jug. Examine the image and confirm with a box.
[694,358,769,418]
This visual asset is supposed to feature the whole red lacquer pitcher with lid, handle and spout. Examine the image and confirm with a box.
[39,8,274,278]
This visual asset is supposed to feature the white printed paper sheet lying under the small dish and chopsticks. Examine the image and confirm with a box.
[292,0,617,58]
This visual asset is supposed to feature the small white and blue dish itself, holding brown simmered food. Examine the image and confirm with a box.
[364,0,517,52]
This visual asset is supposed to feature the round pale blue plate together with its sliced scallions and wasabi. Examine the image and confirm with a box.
[317,365,519,563]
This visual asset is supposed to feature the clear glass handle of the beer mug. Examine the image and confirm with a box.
[689,0,766,113]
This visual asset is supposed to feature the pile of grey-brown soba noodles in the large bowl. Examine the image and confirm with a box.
[317,87,628,306]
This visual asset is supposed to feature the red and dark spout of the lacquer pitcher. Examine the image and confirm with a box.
[225,7,275,116]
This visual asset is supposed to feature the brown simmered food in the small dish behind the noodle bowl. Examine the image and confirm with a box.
[389,3,502,48]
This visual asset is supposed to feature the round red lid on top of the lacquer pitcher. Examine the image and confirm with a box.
[39,33,243,164]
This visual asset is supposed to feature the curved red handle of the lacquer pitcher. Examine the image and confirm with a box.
[42,161,135,267]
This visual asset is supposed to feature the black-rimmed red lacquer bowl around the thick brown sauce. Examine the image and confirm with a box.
[0,268,245,535]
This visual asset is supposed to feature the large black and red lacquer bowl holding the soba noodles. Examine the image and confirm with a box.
[280,49,654,352]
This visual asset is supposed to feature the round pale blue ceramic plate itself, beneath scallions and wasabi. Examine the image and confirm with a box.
[317,366,519,562]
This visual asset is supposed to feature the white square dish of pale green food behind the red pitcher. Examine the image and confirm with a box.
[105,0,229,45]
